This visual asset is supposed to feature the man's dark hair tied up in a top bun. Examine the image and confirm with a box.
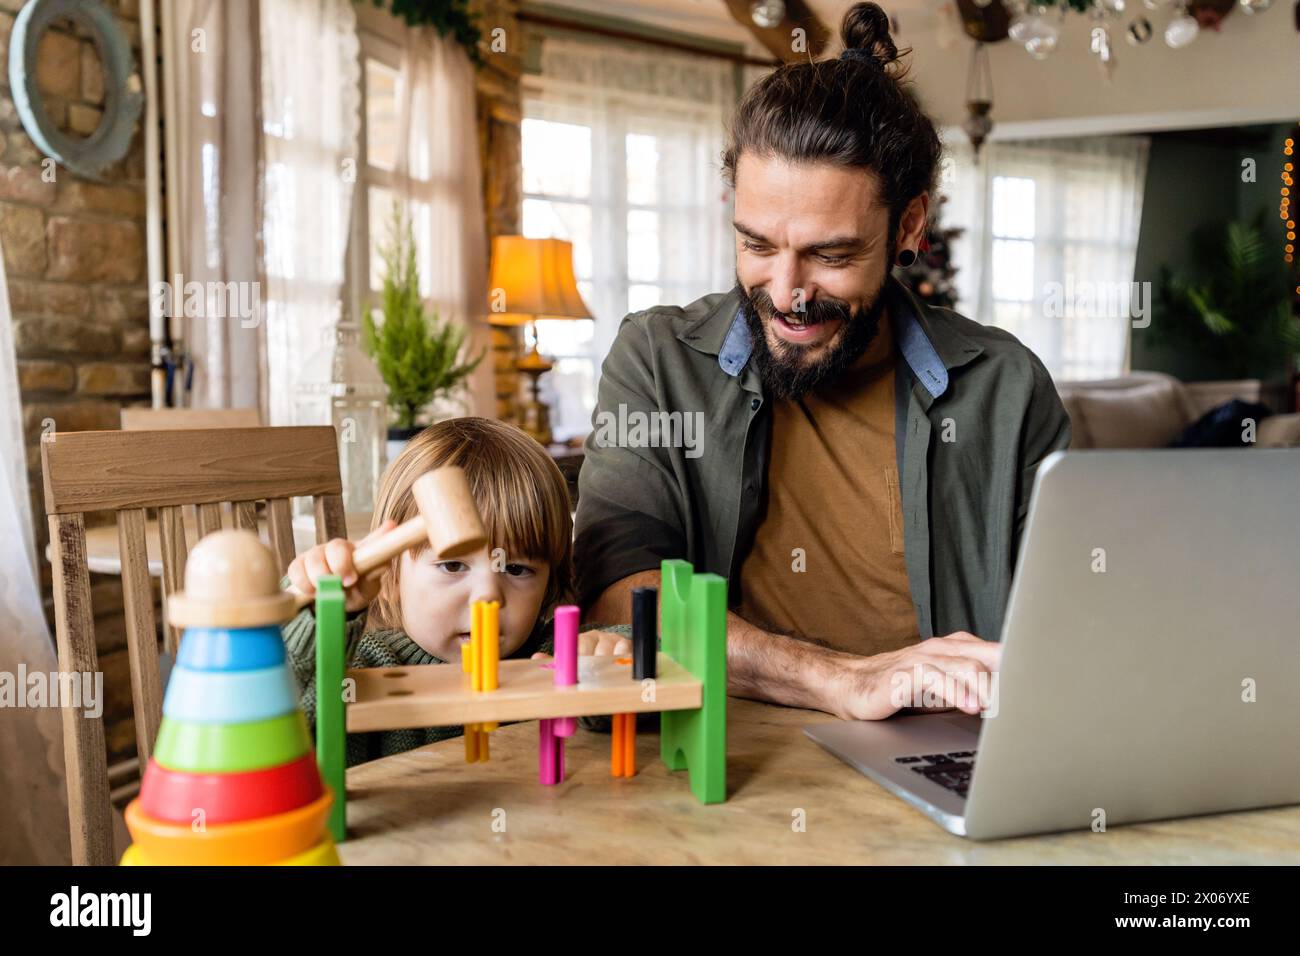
[723,3,943,242]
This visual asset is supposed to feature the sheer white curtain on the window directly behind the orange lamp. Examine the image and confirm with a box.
[524,36,737,440]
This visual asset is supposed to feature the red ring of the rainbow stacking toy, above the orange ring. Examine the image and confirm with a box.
[140,753,325,823]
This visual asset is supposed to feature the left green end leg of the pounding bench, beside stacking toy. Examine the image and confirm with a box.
[316,578,347,843]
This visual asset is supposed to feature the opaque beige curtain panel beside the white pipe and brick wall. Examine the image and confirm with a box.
[163,0,263,408]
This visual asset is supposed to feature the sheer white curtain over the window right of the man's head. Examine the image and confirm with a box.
[940,134,1151,380]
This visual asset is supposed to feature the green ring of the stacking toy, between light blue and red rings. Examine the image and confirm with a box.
[153,710,312,774]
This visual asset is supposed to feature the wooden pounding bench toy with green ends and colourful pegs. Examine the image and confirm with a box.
[316,561,727,840]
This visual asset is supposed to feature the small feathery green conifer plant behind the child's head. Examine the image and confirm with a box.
[361,204,486,458]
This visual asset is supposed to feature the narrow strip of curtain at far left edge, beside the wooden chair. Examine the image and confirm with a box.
[0,240,72,866]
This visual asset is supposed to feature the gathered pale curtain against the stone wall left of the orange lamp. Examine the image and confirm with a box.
[384,27,495,418]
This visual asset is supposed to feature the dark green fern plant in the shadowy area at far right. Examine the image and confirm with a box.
[1152,219,1300,378]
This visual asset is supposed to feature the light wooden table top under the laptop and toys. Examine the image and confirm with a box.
[339,698,1300,865]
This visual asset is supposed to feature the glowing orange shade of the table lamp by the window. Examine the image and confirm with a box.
[488,235,592,325]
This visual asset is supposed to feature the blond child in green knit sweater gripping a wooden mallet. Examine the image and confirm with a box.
[285,418,627,765]
